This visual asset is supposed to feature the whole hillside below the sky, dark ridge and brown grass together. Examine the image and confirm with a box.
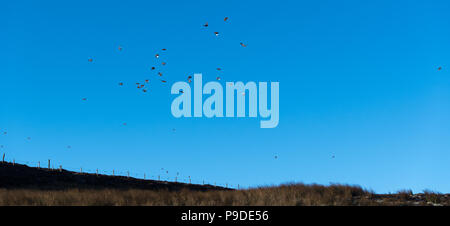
[0,163,450,206]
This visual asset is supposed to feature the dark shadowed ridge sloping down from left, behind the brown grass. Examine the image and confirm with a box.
[0,162,231,191]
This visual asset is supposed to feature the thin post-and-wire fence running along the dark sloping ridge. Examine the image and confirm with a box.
[1,153,242,189]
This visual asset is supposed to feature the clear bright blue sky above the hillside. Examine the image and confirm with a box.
[0,1,450,193]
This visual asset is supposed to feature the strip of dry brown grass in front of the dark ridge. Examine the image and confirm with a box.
[0,184,449,206]
